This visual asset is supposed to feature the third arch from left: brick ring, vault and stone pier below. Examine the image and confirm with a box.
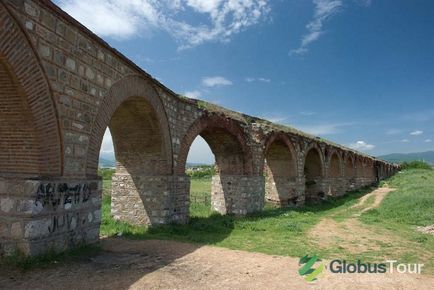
[176,115,264,214]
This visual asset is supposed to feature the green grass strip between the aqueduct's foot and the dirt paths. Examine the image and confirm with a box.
[101,179,369,256]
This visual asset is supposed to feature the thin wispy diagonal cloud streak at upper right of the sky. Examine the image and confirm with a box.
[289,0,342,55]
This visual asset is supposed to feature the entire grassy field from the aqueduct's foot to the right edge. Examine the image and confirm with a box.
[101,169,434,274]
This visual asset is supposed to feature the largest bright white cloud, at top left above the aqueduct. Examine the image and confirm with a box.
[59,0,270,49]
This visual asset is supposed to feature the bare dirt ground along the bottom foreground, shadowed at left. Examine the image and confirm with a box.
[0,238,434,290]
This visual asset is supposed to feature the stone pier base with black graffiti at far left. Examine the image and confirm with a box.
[0,178,102,256]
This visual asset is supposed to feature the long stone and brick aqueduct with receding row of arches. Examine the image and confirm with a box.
[0,0,398,255]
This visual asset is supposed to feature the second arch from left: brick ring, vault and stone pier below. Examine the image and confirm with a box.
[86,75,175,225]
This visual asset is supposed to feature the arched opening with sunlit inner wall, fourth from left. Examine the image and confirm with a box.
[264,137,299,206]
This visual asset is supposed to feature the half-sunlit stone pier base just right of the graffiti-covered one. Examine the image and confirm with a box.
[111,174,190,225]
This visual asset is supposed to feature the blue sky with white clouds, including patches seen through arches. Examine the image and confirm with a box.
[55,0,434,162]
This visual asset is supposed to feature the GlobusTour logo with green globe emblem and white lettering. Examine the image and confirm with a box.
[298,255,424,282]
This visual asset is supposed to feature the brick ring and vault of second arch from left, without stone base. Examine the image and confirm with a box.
[86,75,172,177]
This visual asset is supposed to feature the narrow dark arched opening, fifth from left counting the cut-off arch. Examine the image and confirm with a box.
[304,147,325,201]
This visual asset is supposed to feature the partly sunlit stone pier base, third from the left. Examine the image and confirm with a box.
[211,175,265,215]
